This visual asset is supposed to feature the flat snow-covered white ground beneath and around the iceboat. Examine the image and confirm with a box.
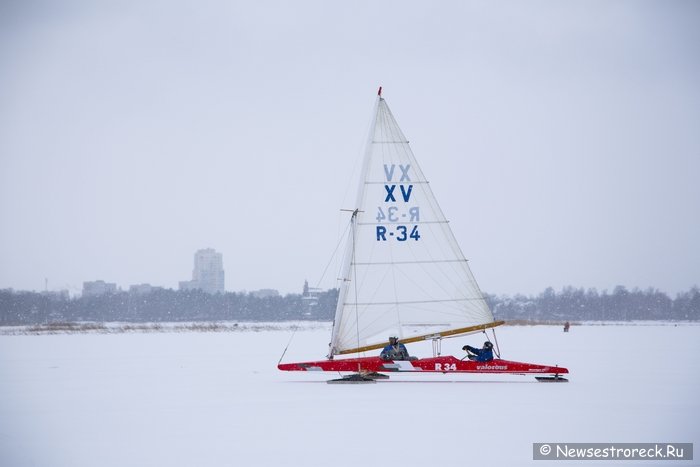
[0,325,700,467]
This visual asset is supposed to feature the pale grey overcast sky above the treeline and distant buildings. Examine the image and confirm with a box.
[0,0,700,295]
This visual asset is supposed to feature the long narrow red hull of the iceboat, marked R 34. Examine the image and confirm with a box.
[277,356,569,375]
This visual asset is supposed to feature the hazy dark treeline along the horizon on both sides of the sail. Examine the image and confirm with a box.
[0,286,700,326]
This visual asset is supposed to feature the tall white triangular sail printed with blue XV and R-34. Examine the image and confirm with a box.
[330,96,494,356]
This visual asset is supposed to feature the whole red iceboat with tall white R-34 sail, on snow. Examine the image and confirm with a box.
[278,88,569,383]
